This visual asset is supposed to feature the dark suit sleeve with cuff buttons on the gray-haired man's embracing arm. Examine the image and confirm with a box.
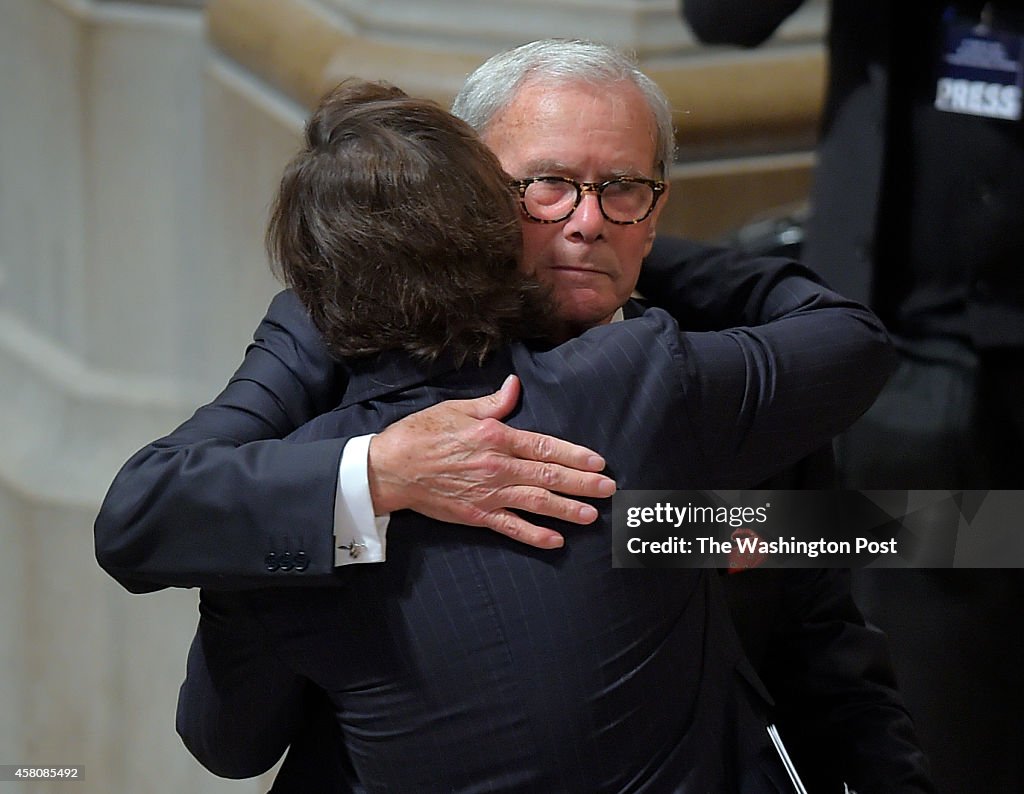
[94,292,348,592]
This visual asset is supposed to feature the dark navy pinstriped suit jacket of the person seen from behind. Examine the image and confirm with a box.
[179,283,889,792]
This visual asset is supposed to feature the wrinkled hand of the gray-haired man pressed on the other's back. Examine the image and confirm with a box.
[369,376,615,548]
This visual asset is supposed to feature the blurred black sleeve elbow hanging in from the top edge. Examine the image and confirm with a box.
[681,0,804,47]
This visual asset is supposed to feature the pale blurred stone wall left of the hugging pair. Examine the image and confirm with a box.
[0,0,294,792]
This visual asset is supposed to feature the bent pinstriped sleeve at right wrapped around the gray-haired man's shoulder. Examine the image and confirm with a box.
[655,250,895,488]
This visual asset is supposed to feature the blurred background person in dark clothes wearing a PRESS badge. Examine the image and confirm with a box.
[682,0,1024,794]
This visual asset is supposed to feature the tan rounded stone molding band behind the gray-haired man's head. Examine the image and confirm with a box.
[208,0,824,159]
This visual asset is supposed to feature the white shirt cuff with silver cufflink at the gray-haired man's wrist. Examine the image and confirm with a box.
[334,434,391,568]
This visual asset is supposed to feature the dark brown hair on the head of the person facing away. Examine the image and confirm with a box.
[266,81,545,361]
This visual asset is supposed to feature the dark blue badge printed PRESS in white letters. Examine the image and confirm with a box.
[935,5,1024,121]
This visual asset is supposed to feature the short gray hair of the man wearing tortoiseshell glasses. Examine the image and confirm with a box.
[452,39,676,177]
